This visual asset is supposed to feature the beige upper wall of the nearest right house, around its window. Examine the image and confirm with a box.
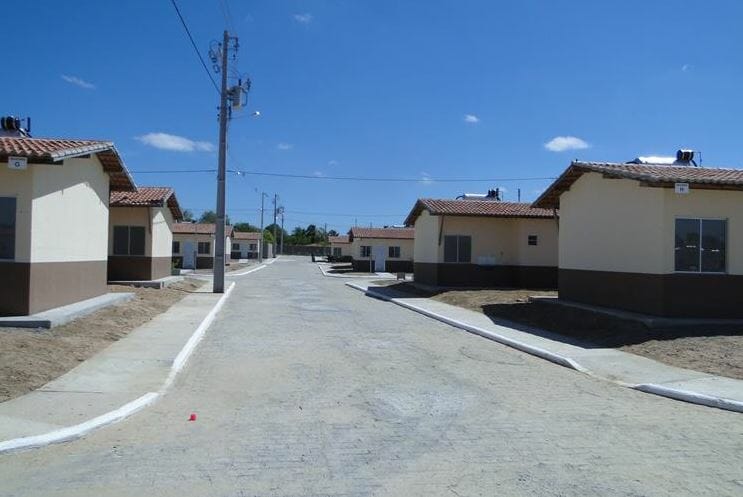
[559,173,743,274]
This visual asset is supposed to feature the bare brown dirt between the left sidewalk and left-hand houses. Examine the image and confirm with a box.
[0,279,204,402]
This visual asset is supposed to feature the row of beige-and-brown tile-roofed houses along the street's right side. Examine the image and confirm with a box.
[331,151,743,318]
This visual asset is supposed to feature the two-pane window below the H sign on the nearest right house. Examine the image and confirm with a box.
[674,219,727,273]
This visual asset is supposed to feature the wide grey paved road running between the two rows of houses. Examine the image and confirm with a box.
[0,258,743,497]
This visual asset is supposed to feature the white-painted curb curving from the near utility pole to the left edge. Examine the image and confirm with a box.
[0,281,235,454]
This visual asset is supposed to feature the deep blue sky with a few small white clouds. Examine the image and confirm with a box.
[5,0,743,231]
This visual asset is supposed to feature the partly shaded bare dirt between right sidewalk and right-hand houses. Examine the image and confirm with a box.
[380,283,743,379]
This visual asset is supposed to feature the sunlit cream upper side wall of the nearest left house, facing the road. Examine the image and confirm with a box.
[29,156,109,262]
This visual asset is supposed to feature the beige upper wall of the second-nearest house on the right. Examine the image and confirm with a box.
[415,211,558,267]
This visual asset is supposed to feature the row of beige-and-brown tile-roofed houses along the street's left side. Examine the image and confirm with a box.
[0,136,272,316]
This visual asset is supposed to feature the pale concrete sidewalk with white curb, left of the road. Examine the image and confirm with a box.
[0,283,234,452]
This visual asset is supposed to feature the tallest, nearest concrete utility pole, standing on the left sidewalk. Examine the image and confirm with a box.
[212,30,230,293]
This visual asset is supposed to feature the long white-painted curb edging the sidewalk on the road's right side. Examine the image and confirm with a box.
[346,282,743,413]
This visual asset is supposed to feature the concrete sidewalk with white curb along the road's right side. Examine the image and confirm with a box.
[346,282,743,412]
